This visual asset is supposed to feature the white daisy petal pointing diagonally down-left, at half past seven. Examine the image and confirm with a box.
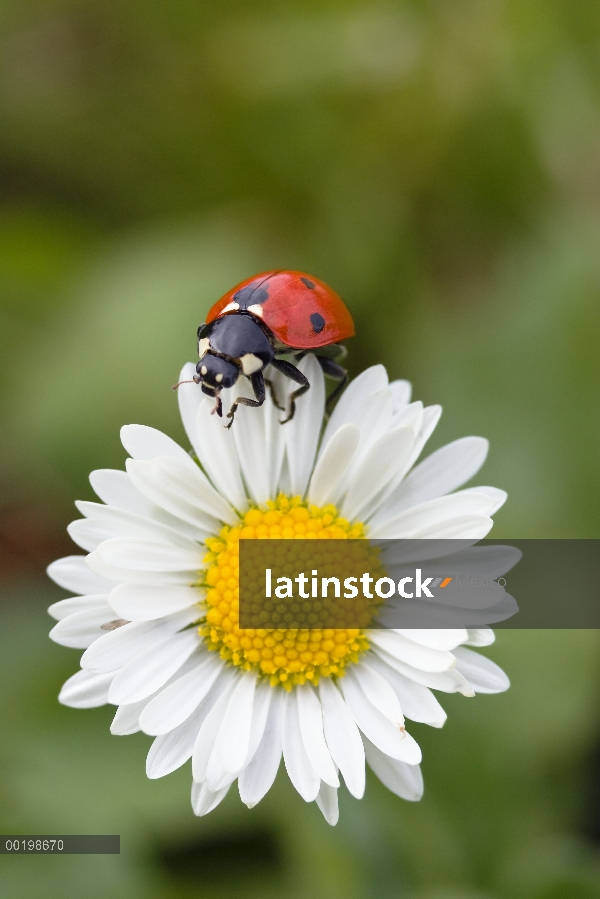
[140,653,224,736]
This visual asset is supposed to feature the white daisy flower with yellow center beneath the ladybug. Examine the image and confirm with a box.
[48,355,508,824]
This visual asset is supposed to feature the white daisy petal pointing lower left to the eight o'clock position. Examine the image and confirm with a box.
[108,630,199,705]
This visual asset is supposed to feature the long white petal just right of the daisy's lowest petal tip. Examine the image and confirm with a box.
[319,678,365,799]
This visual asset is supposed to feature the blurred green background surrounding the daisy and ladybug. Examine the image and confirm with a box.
[0,0,600,899]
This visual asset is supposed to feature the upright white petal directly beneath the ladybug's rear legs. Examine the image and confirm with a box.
[285,353,325,496]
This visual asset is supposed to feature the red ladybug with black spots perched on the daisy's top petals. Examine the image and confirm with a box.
[180,271,354,428]
